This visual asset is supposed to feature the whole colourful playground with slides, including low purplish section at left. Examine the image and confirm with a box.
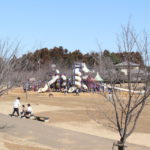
[23,63,105,93]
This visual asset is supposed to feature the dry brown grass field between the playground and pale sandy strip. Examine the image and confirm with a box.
[0,88,150,133]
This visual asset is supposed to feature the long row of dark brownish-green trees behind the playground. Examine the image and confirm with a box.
[12,47,143,71]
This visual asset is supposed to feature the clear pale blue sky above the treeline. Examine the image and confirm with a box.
[0,0,150,55]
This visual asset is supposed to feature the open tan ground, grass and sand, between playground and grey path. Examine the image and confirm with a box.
[0,88,150,150]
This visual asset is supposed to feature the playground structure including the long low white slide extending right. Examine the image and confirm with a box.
[24,60,144,94]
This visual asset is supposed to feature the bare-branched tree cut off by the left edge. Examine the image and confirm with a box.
[0,40,20,96]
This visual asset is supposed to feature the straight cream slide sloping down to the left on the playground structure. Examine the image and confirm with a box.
[38,75,59,93]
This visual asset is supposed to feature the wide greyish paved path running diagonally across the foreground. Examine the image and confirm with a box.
[0,114,150,150]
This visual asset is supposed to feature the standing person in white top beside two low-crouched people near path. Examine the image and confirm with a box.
[11,97,33,117]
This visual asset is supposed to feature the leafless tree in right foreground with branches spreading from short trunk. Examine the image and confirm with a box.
[96,24,150,150]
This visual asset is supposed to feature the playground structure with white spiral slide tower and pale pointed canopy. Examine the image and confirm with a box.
[24,63,103,93]
